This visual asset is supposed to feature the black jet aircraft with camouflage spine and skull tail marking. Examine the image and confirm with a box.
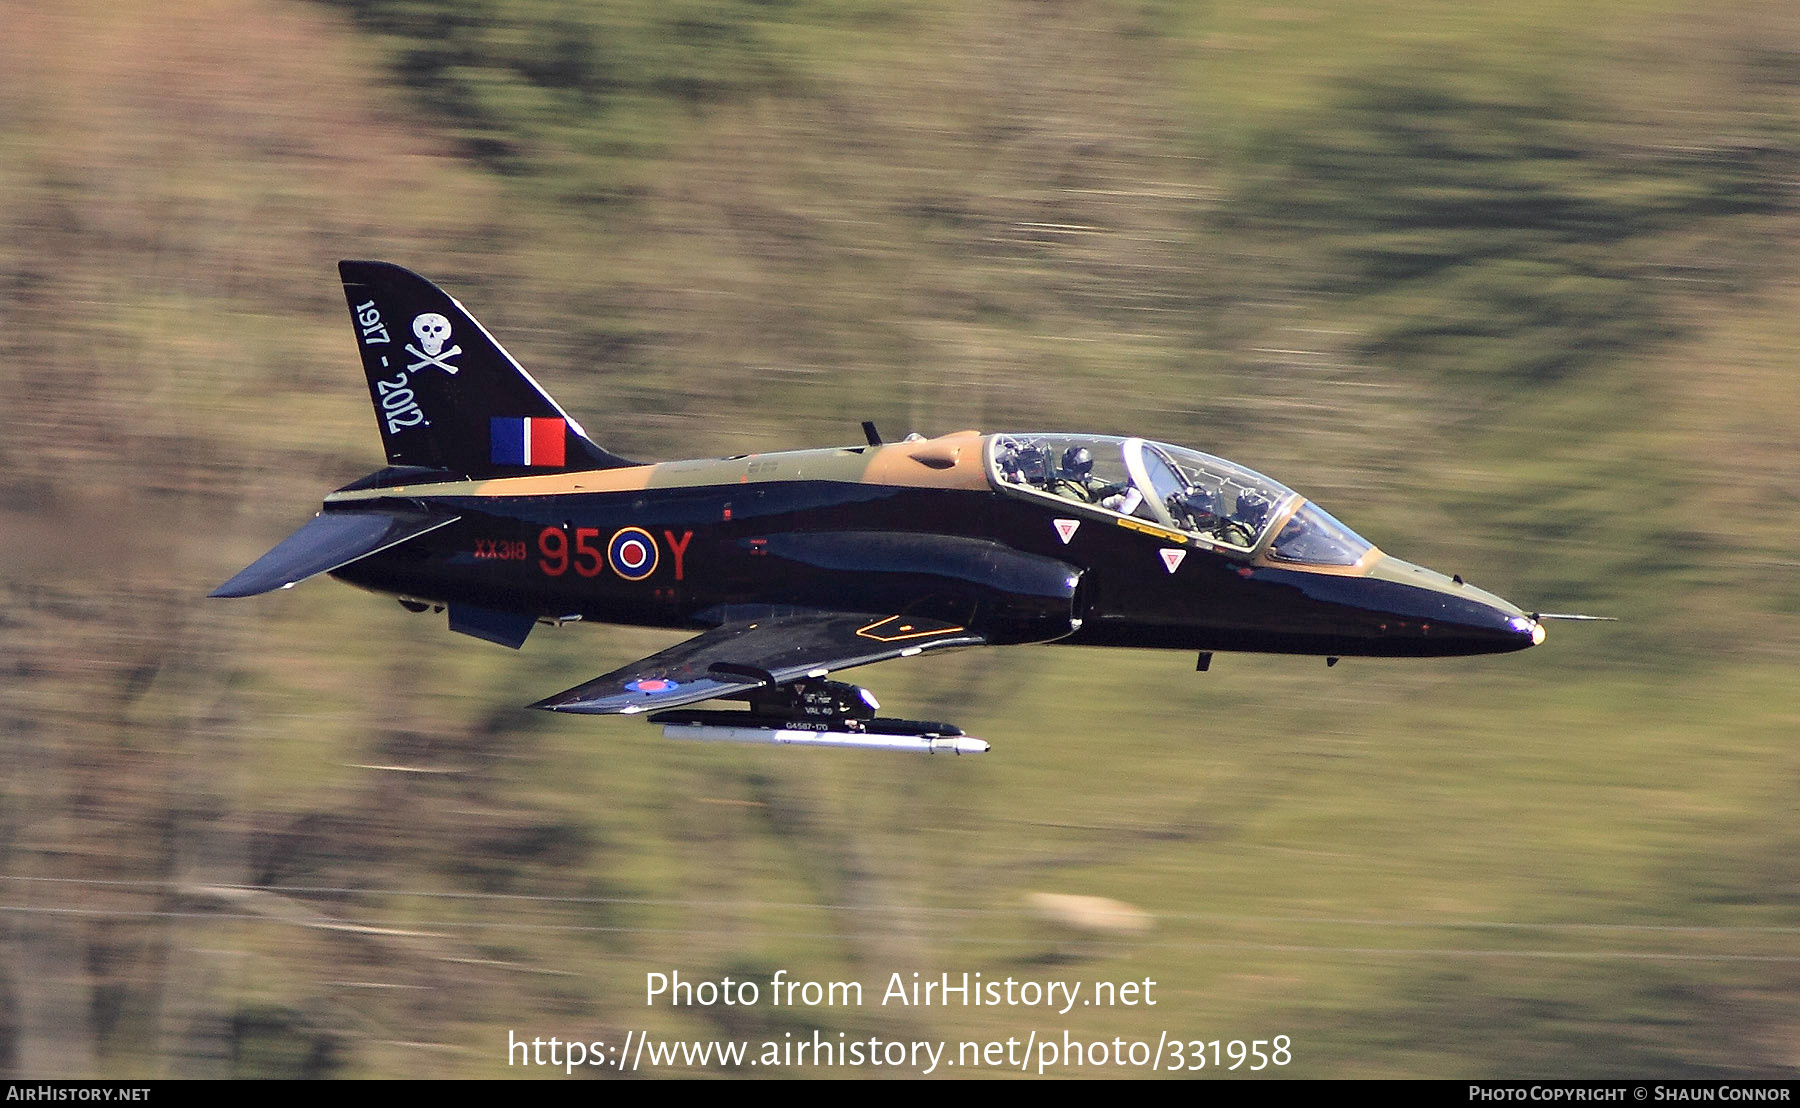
[212,261,1544,754]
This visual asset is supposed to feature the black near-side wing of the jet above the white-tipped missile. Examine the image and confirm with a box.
[531,612,986,716]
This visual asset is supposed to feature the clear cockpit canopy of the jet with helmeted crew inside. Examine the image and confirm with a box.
[988,433,1372,565]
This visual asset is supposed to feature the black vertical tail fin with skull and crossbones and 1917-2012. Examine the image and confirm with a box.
[338,261,634,477]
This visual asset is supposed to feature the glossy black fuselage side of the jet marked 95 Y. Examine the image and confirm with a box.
[337,480,1534,657]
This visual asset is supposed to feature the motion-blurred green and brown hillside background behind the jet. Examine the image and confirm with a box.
[0,0,1800,1077]
